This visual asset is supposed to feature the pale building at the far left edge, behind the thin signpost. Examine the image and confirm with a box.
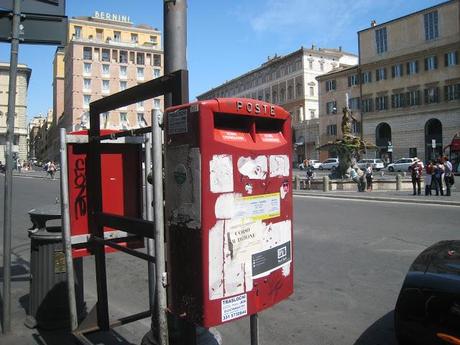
[0,63,32,163]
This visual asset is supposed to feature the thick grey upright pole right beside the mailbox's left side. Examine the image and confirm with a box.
[152,109,169,345]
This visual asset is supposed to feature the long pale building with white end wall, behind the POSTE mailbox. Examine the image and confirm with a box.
[197,46,358,162]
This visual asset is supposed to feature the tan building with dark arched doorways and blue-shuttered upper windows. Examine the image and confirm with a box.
[320,0,460,163]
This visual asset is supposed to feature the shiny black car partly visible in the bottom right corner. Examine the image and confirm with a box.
[394,241,460,345]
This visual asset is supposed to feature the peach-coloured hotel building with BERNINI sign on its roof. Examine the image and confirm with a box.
[48,12,163,159]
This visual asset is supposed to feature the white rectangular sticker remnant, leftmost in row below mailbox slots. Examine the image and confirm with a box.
[209,155,233,193]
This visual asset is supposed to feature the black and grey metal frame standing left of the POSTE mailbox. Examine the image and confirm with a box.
[60,70,188,345]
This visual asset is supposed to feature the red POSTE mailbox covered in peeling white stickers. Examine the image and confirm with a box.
[165,98,293,327]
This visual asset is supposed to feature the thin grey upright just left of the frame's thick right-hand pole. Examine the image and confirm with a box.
[144,133,155,315]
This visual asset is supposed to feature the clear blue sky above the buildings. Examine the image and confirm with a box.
[0,0,444,119]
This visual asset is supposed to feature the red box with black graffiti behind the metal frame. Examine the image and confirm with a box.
[67,130,143,258]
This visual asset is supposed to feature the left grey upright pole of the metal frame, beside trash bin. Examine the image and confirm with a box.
[59,128,78,331]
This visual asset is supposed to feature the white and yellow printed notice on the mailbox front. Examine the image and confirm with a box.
[235,193,281,220]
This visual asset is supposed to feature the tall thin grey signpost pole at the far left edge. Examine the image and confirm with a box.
[3,0,21,334]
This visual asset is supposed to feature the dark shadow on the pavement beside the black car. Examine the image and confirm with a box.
[353,311,398,345]
